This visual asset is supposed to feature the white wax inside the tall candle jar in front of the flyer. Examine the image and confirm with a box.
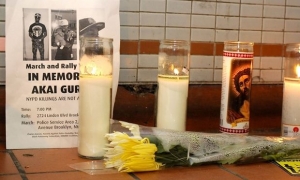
[78,76,112,157]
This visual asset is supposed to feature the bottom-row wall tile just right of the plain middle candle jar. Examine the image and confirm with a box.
[190,69,214,82]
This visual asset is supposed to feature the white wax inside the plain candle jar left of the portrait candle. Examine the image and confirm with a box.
[156,76,189,131]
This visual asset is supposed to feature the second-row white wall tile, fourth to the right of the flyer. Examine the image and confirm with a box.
[191,15,216,28]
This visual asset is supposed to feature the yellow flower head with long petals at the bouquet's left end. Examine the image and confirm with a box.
[104,132,163,172]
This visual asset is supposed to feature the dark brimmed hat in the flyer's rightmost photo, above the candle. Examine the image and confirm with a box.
[79,18,105,36]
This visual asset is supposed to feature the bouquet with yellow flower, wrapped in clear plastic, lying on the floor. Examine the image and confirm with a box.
[104,120,300,172]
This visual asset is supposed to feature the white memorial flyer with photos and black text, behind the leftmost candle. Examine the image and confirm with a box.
[6,0,120,149]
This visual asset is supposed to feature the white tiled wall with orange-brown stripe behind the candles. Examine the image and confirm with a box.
[0,0,300,84]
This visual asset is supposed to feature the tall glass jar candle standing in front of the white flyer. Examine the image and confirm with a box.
[78,37,113,159]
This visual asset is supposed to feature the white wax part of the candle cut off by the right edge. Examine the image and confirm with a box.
[282,80,300,136]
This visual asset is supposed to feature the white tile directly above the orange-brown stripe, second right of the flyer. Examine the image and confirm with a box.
[140,27,165,40]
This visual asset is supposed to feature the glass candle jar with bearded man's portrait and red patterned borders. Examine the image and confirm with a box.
[220,41,254,134]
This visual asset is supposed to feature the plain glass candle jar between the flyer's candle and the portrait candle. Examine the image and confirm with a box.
[156,40,190,131]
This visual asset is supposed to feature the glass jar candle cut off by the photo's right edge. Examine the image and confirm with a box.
[281,44,300,137]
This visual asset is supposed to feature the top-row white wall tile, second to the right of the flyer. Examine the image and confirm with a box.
[140,0,166,12]
